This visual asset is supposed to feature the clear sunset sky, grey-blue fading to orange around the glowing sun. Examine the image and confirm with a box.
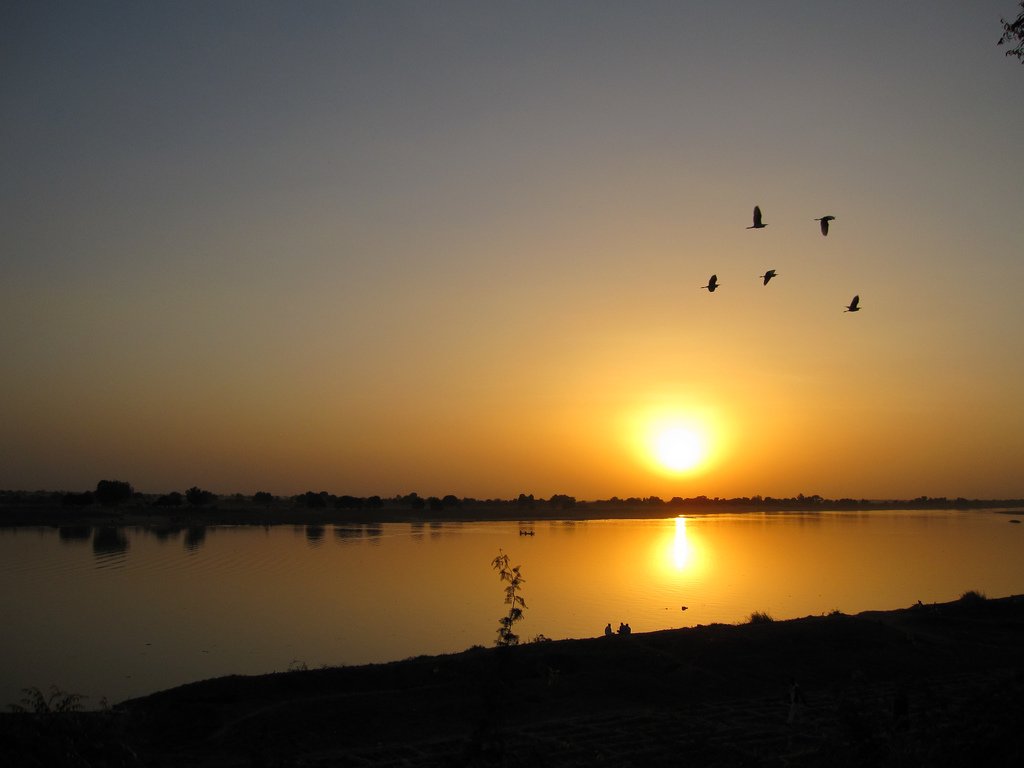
[0,0,1024,499]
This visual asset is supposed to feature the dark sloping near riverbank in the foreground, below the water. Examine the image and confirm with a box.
[0,596,1024,768]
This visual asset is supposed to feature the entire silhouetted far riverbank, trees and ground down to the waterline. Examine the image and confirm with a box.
[0,480,1024,526]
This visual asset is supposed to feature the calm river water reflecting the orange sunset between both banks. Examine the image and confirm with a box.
[0,511,1024,707]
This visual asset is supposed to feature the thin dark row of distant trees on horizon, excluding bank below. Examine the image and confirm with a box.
[0,480,1024,514]
